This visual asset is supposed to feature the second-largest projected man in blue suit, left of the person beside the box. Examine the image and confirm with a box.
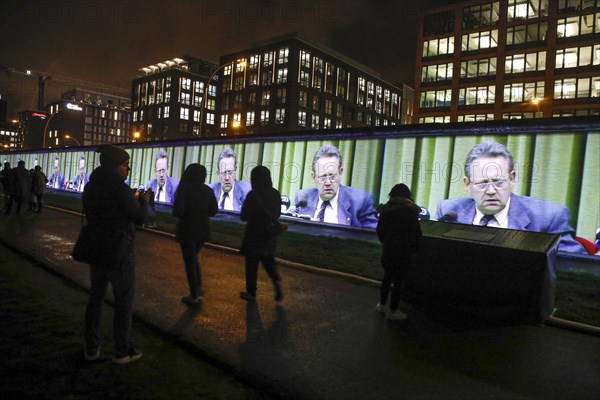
[294,144,377,228]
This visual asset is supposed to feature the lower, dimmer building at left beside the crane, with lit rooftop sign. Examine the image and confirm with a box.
[41,89,131,148]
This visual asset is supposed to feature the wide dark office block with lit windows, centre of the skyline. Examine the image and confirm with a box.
[211,34,413,136]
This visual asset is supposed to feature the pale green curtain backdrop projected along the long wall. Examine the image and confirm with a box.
[3,123,600,255]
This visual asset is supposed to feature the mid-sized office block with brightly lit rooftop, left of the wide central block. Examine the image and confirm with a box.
[131,56,217,141]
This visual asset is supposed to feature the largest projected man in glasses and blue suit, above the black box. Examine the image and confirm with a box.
[437,141,585,253]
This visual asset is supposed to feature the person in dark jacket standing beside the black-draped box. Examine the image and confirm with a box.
[376,183,422,320]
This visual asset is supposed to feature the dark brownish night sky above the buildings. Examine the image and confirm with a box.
[0,0,447,118]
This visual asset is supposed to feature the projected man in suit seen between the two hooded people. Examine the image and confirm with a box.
[210,147,252,212]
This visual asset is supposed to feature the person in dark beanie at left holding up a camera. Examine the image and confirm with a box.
[83,144,148,364]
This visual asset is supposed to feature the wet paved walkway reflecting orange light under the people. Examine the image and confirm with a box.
[0,208,600,400]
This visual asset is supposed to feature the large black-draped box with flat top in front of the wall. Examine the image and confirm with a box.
[402,221,559,324]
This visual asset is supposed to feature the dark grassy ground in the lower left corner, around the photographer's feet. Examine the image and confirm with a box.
[0,246,271,400]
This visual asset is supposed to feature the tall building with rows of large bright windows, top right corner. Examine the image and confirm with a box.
[415,0,600,123]
